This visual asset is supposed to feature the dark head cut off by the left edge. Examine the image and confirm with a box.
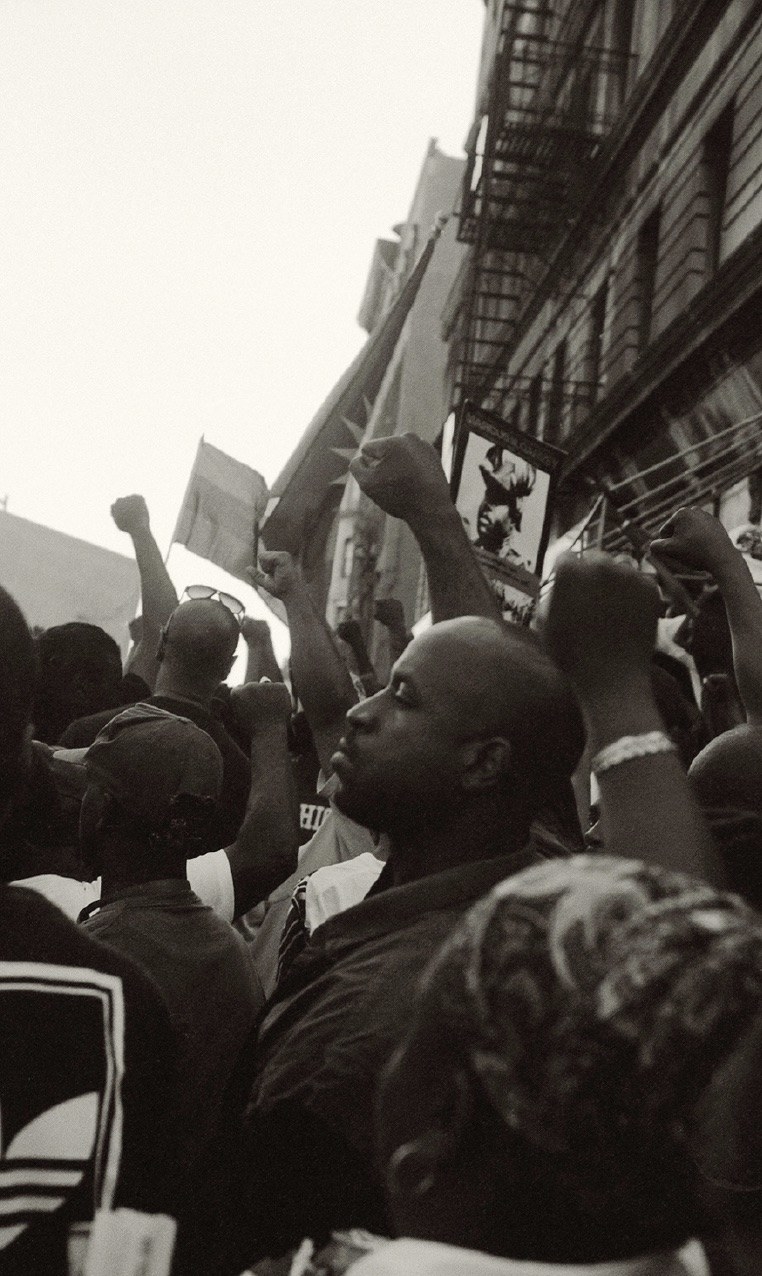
[0,588,36,822]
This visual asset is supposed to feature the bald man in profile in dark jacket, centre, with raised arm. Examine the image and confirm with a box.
[223,438,583,1265]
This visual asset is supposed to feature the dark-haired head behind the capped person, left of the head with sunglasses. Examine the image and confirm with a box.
[33,621,121,744]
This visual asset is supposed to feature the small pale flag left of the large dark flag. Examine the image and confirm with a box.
[172,438,268,581]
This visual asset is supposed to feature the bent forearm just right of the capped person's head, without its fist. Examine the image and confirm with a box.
[227,722,299,916]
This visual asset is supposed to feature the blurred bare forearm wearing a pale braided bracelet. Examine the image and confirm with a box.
[585,679,722,884]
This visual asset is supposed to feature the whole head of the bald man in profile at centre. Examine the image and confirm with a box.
[334,616,585,831]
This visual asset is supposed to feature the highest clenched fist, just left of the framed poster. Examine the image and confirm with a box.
[350,434,451,521]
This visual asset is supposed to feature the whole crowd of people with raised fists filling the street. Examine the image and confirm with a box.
[0,435,762,1276]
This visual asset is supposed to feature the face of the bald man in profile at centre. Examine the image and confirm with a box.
[333,630,477,832]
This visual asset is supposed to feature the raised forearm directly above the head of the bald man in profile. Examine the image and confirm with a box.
[410,505,502,624]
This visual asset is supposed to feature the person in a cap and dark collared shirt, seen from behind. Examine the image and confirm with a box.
[80,704,263,1194]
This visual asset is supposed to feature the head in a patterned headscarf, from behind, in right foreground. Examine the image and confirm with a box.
[380,856,762,1263]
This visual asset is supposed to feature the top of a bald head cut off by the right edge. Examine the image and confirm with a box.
[688,723,762,814]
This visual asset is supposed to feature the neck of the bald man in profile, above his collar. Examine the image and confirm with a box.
[389,806,528,886]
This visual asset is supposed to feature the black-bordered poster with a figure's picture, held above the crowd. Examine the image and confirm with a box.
[451,403,564,623]
